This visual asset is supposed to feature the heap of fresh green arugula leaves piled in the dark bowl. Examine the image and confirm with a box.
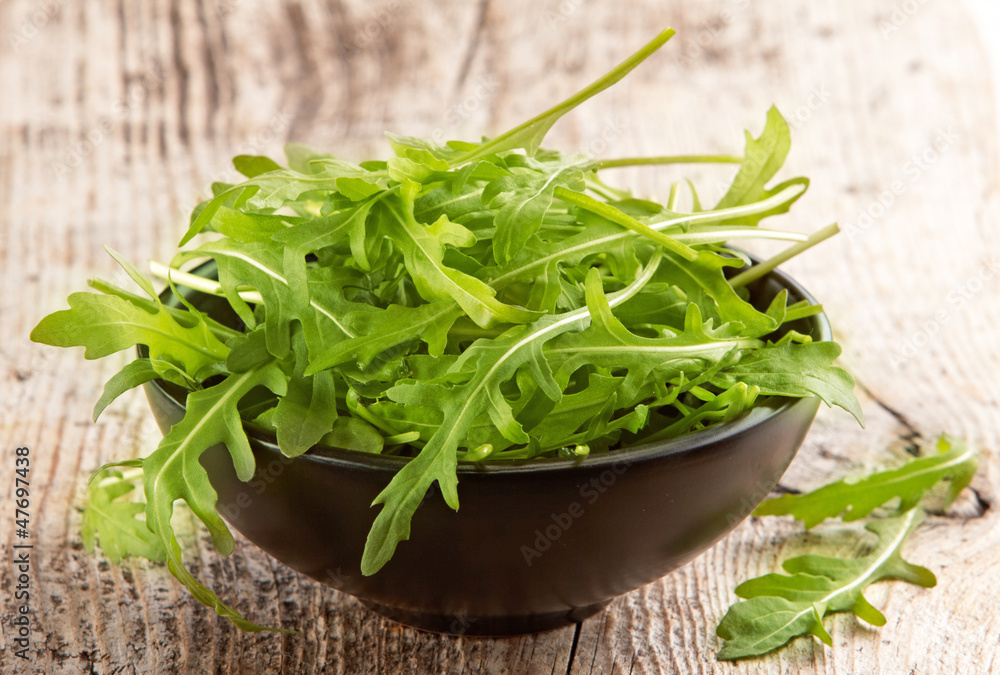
[31,29,861,629]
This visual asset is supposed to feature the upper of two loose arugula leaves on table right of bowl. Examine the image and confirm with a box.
[754,434,976,527]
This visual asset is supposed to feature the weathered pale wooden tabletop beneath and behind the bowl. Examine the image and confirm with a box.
[0,0,1000,674]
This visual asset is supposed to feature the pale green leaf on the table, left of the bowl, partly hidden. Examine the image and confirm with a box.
[81,469,166,565]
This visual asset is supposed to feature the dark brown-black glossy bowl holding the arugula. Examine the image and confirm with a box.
[145,268,831,636]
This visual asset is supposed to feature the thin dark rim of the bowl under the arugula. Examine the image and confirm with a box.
[143,258,833,476]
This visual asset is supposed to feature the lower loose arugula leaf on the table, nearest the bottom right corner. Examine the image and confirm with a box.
[716,509,937,660]
